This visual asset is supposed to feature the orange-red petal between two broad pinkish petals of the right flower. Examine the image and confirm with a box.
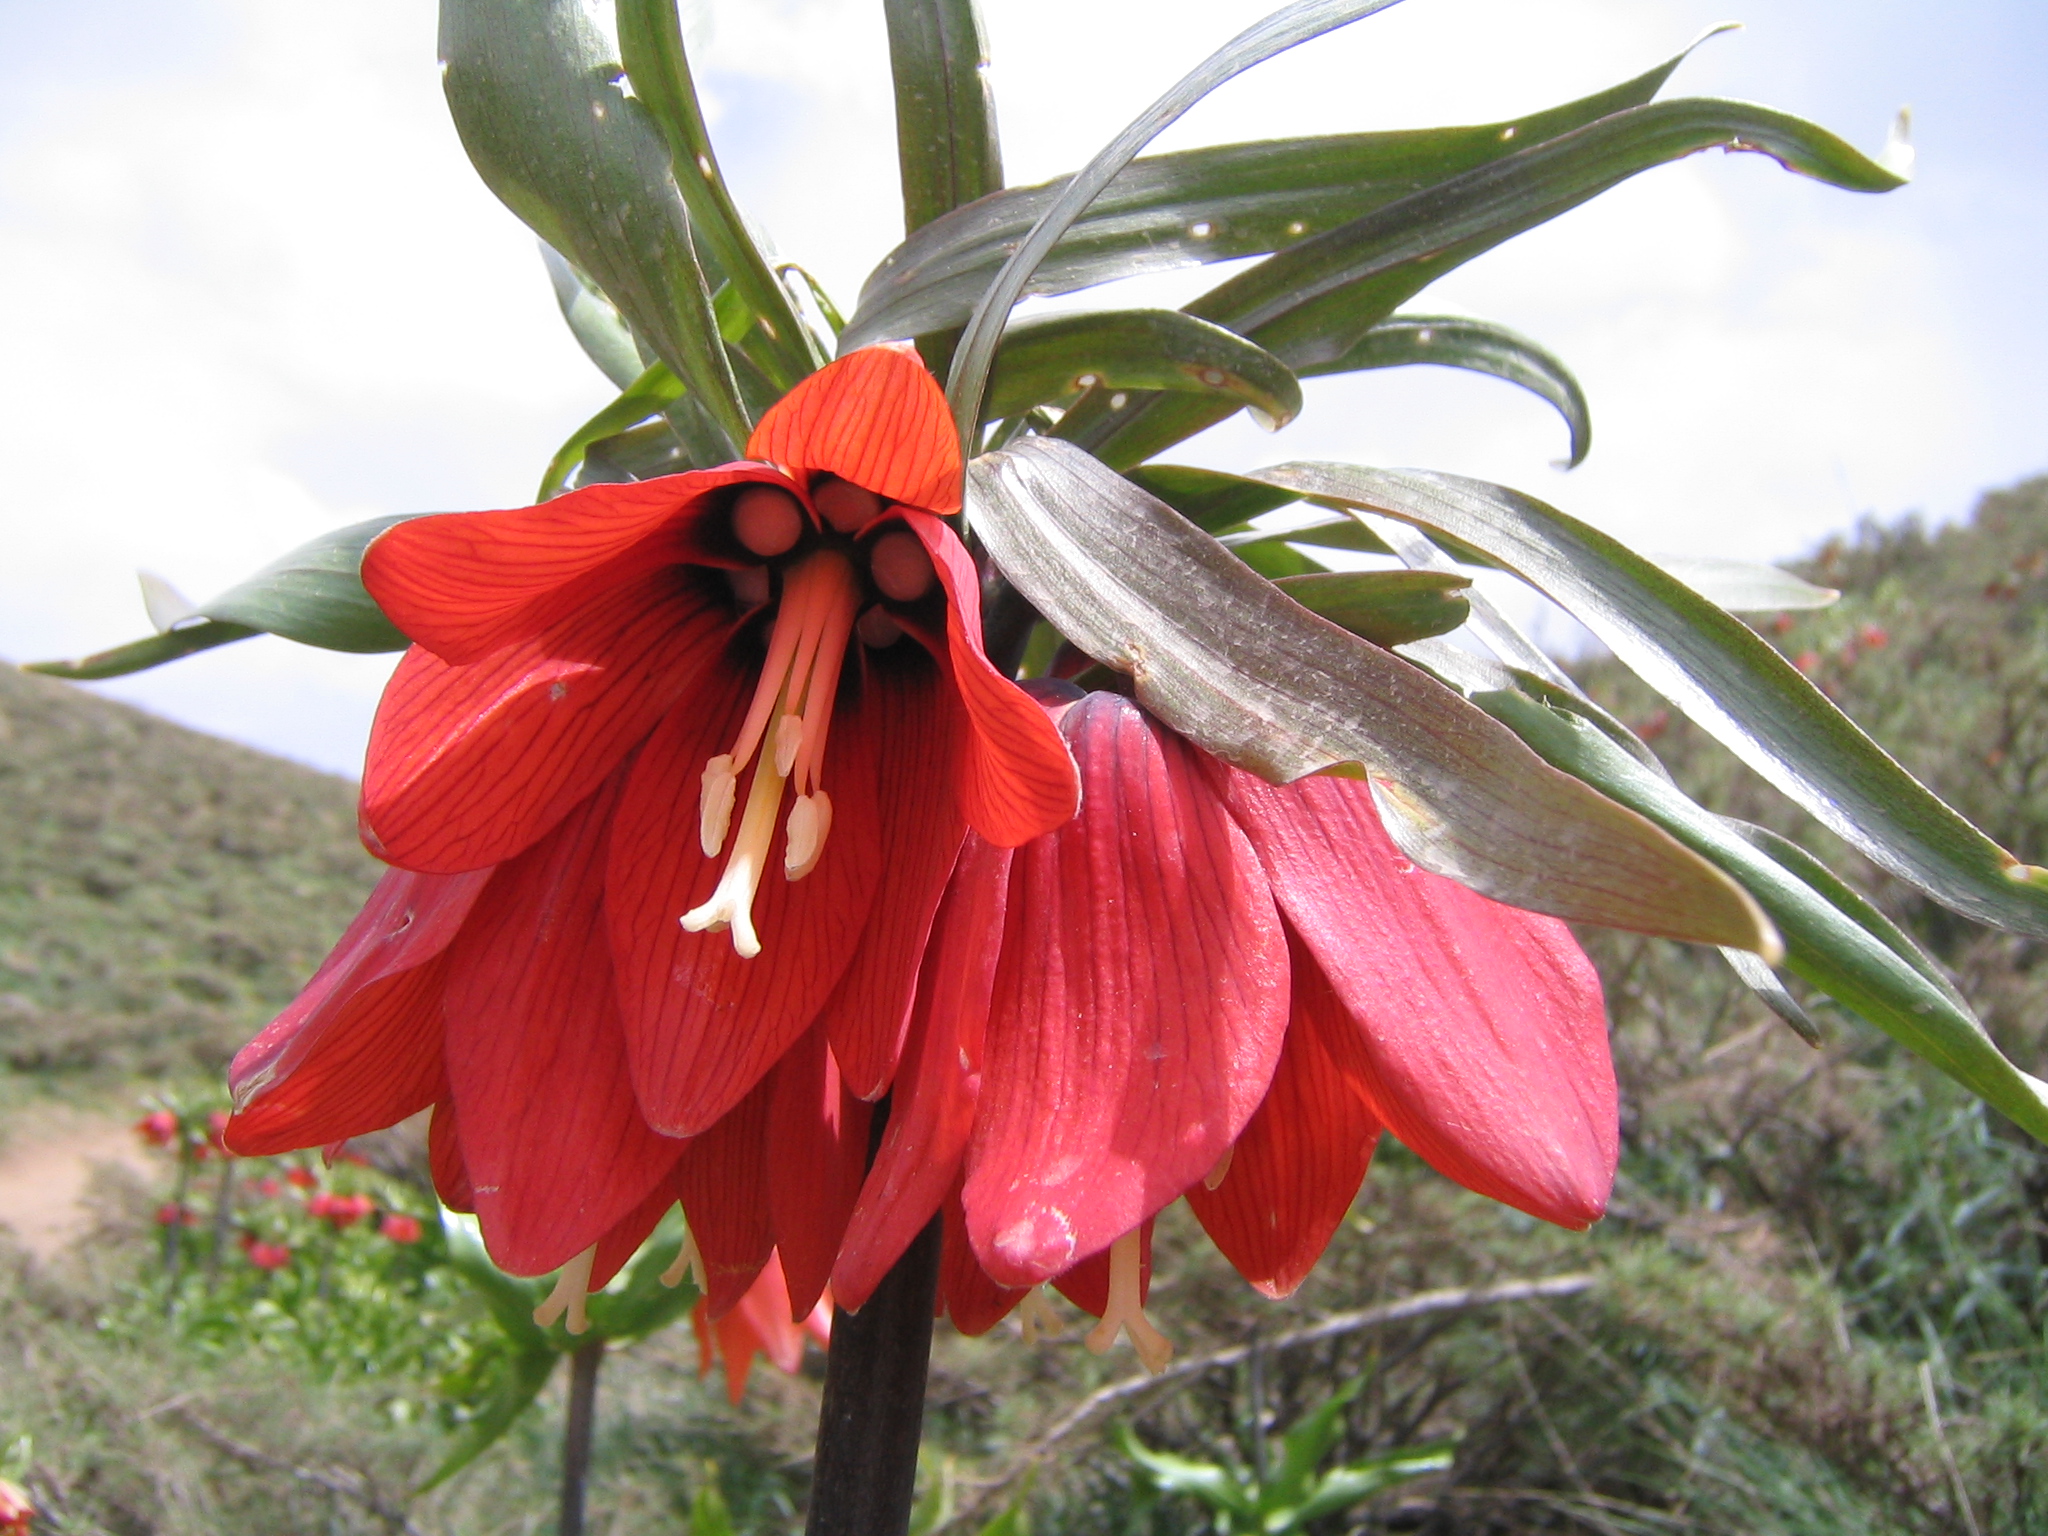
[1188,954,1380,1298]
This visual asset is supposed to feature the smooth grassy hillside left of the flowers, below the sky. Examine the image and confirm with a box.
[0,668,377,1094]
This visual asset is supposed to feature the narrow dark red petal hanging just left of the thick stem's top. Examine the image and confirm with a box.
[768,1024,870,1323]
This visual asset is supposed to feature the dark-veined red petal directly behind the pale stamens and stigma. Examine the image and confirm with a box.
[606,674,889,1137]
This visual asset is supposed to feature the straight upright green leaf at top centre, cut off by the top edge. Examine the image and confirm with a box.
[883,0,1004,233]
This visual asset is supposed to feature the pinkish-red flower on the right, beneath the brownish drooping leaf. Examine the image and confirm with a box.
[831,684,1618,1368]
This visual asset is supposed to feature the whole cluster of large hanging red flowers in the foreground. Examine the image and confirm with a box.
[227,346,1616,1382]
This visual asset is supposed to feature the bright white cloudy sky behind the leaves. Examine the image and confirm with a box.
[0,0,2048,774]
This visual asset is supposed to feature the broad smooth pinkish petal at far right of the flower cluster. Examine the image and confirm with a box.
[1212,764,1618,1227]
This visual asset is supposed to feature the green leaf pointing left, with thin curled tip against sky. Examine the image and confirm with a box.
[27,514,416,682]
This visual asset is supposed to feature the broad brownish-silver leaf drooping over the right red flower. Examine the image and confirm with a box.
[967,438,1776,950]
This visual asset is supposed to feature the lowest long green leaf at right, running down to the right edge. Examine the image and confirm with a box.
[1475,690,2048,1141]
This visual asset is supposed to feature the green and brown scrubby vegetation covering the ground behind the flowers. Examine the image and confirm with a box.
[0,481,2048,1536]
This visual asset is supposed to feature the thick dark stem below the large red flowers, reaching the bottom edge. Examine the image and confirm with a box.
[803,1217,940,1536]
